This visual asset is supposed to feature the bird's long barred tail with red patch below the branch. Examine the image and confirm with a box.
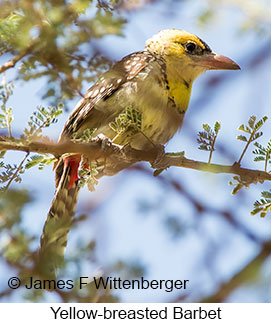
[39,155,80,278]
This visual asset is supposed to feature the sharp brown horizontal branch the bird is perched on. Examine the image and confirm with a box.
[0,137,271,183]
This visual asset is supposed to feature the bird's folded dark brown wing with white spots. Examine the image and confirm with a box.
[60,51,156,139]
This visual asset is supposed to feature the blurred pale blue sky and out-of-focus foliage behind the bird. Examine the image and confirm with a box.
[0,0,271,302]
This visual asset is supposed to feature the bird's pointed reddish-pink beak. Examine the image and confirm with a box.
[193,53,240,70]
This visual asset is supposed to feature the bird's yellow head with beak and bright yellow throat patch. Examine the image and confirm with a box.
[145,29,240,111]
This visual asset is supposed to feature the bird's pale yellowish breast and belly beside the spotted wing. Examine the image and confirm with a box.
[93,60,189,149]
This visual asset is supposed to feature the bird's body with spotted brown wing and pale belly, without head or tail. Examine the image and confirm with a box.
[61,51,186,149]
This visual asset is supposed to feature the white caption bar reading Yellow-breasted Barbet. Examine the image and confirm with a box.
[0,303,271,323]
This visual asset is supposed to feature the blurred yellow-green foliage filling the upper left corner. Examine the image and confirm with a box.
[0,0,125,105]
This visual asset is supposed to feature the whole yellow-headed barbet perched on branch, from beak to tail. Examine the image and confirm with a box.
[39,29,240,276]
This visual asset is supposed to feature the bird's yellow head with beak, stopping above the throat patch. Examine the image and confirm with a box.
[146,29,240,83]
